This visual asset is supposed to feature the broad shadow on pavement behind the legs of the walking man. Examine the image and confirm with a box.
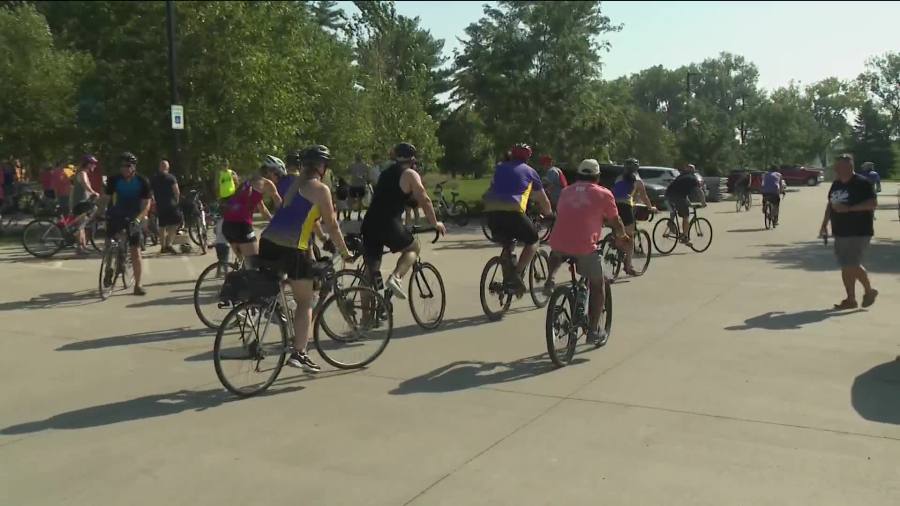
[742,238,900,272]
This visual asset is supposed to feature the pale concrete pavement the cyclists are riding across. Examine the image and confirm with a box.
[0,184,900,506]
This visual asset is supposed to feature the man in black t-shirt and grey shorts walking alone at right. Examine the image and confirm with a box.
[820,155,878,309]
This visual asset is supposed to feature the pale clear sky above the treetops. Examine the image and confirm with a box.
[338,1,900,90]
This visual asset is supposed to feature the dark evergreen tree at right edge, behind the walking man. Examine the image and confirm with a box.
[847,101,897,177]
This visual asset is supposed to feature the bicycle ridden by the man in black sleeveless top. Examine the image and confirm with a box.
[337,226,447,330]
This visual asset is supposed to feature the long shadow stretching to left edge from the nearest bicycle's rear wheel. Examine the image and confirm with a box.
[0,386,304,435]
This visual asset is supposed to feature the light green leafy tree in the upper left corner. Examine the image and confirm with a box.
[0,4,91,164]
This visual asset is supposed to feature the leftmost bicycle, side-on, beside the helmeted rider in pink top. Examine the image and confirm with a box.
[22,200,101,258]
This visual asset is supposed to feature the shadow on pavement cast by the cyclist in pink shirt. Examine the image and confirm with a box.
[390,354,587,395]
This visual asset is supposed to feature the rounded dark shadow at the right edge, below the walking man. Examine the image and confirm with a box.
[850,357,900,425]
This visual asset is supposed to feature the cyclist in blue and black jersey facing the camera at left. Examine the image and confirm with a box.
[103,152,150,295]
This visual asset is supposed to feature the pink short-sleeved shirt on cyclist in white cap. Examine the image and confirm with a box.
[550,181,619,255]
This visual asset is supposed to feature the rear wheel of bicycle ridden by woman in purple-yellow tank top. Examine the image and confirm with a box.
[213,302,289,397]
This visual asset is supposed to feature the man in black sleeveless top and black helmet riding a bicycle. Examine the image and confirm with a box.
[361,142,447,299]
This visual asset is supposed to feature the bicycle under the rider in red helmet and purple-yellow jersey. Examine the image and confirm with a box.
[479,230,550,321]
